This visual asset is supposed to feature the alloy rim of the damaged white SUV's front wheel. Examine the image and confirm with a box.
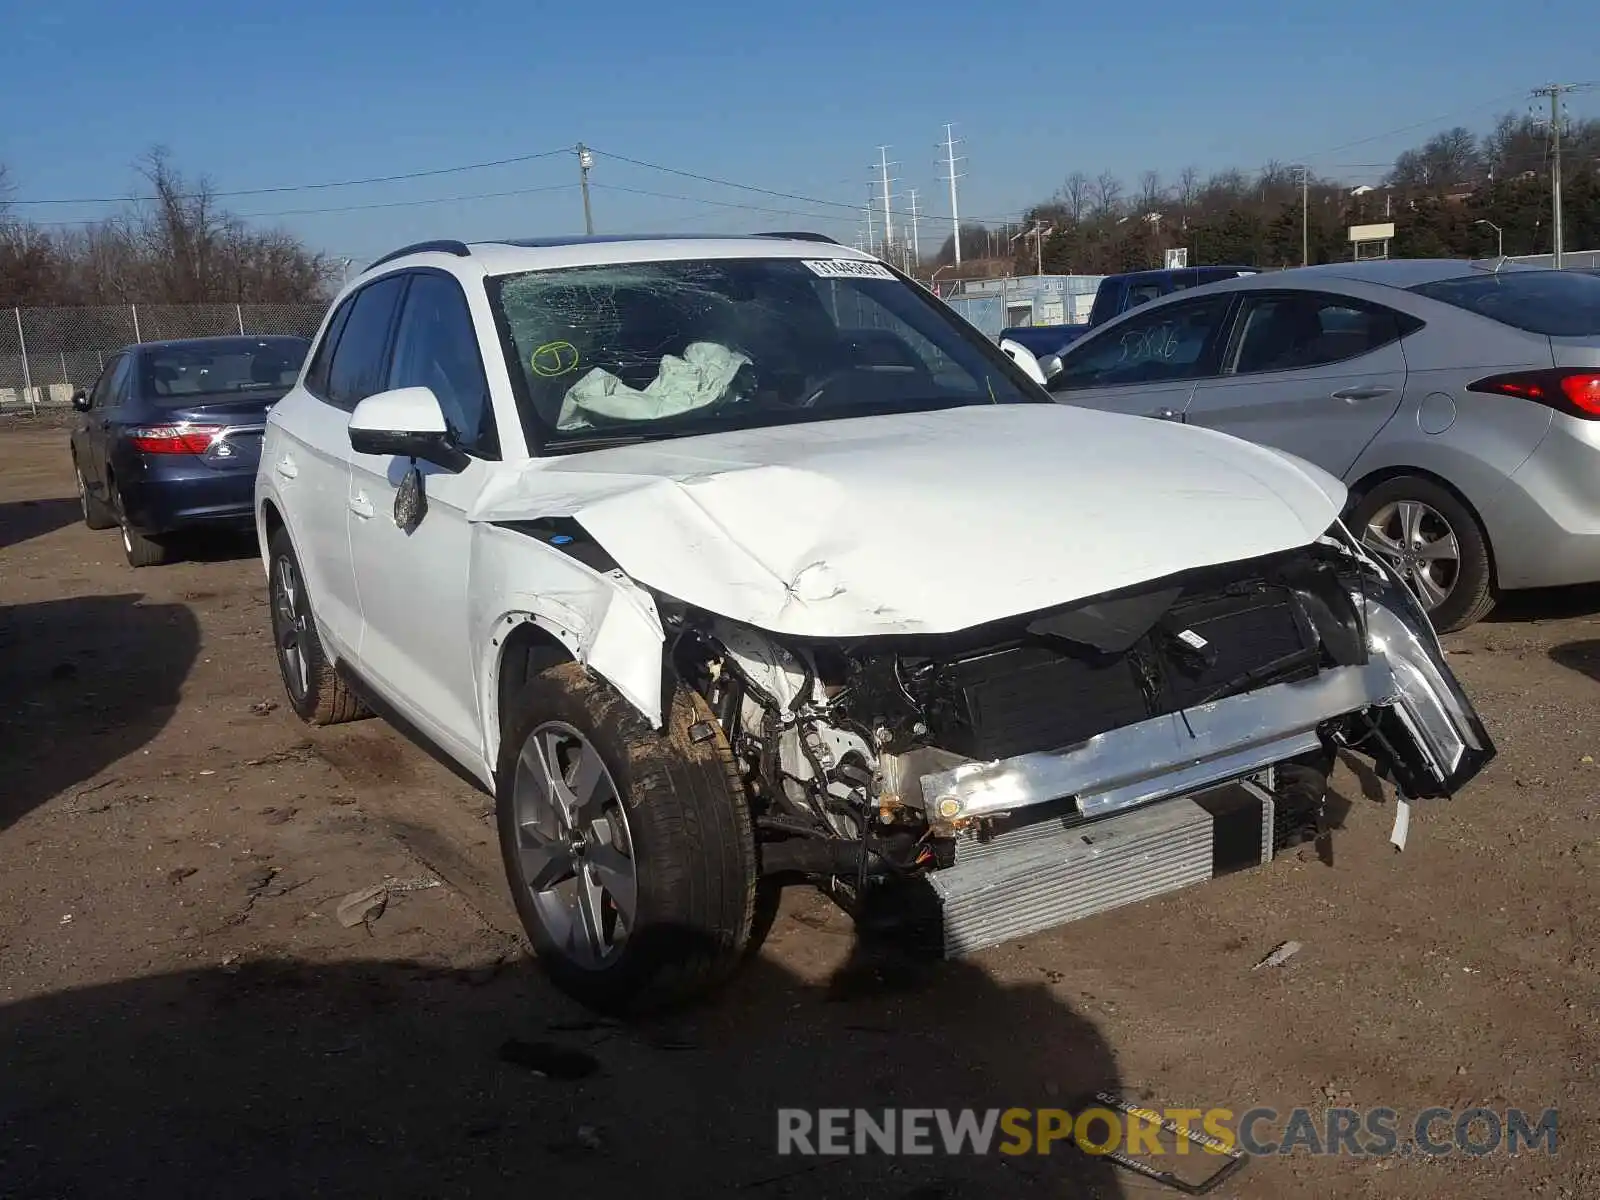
[512,722,638,970]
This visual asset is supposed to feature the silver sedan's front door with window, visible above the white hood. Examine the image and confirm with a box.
[1045,293,1234,421]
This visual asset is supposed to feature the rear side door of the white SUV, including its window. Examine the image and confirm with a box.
[262,277,403,659]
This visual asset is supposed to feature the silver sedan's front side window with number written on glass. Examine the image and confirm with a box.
[1048,296,1232,392]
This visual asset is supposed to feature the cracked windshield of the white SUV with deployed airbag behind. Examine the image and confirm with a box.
[494,258,1037,440]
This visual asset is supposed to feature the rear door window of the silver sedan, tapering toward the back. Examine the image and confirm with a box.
[1229,291,1402,374]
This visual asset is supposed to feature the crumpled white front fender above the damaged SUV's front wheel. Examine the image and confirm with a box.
[467,523,666,762]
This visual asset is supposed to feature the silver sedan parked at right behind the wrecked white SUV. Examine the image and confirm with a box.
[1042,259,1600,632]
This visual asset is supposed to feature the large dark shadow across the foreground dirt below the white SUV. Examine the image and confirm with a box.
[0,928,1126,1200]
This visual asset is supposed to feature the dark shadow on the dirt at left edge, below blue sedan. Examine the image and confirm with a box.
[0,594,200,830]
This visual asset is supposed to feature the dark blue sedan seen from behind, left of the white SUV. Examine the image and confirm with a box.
[72,338,310,566]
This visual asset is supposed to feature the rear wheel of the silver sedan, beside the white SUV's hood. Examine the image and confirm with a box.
[1350,475,1494,634]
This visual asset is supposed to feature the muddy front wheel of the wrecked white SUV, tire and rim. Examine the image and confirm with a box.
[496,662,757,1014]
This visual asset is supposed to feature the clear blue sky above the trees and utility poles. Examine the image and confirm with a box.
[0,0,1600,262]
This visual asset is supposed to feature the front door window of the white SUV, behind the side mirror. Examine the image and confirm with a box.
[387,274,499,459]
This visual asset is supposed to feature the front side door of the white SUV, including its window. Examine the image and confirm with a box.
[349,270,501,770]
